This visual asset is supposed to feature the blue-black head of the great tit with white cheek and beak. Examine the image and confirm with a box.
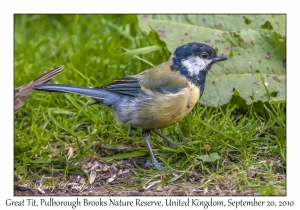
[170,42,228,86]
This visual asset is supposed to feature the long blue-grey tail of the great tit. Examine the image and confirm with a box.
[33,84,120,106]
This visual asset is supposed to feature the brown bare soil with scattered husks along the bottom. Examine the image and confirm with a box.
[14,159,262,196]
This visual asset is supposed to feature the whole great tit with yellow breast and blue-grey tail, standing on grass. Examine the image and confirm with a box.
[33,42,228,171]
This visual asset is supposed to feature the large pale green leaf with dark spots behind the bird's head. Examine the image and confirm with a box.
[138,15,286,105]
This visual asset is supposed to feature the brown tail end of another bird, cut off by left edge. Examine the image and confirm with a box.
[14,66,64,114]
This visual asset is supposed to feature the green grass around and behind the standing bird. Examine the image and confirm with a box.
[14,15,286,195]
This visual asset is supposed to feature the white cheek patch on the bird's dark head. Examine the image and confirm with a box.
[181,57,211,76]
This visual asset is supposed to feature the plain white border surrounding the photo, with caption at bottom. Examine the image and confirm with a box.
[0,0,300,209]
